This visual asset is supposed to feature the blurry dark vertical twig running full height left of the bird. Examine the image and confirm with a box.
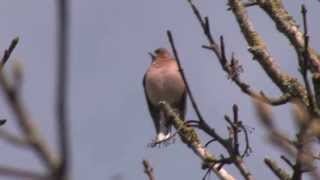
[56,0,70,179]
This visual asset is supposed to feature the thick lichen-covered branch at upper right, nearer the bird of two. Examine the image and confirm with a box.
[229,0,309,107]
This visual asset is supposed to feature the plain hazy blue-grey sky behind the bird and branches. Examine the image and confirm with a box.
[0,0,320,180]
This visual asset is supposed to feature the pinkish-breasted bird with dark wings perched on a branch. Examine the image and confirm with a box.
[143,48,186,142]
